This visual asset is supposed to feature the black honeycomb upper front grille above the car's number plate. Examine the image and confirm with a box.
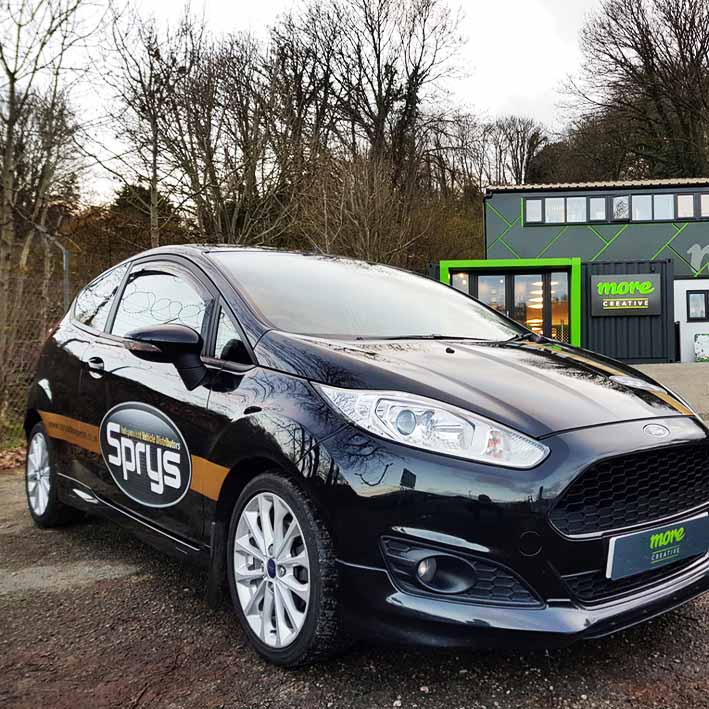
[550,444,709,536]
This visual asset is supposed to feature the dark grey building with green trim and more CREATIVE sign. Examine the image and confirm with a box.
[440,178,709,361]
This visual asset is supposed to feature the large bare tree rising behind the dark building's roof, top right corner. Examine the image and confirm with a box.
[574,0,709,177]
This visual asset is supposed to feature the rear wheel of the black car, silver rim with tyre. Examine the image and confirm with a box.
[25,423,81,529]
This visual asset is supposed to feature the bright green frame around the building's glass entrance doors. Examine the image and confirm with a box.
[439,258,581,347]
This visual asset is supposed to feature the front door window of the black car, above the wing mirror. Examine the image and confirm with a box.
[112,265,212,337]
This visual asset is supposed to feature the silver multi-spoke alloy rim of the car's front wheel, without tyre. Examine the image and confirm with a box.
[234,492,311,648]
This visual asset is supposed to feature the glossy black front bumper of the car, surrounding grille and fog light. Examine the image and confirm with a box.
[312,418,709,647]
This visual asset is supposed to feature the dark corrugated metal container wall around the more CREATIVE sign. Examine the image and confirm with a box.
[581,260,675,363]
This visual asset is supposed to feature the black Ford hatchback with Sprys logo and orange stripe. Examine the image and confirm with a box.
[25,246,709,665]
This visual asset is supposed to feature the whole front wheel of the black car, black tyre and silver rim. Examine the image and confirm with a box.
[227,472,347,667]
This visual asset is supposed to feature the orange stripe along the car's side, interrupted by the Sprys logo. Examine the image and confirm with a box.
[39,411,229,500]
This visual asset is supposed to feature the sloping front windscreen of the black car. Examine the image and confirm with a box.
[210,251,526,340]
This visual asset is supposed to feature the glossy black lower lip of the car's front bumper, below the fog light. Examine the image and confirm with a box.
[340,557,709,648]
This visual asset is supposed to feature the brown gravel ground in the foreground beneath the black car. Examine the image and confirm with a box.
[0,464,709,709]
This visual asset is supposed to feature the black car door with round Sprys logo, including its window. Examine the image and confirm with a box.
[86,257,217,541]
